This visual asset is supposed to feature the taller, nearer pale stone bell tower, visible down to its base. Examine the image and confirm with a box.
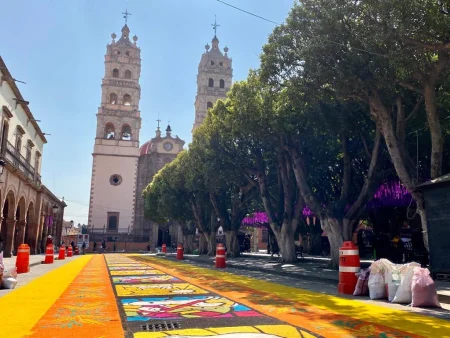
[88,12,141,238]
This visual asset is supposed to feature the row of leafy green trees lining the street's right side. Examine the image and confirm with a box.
[143,0,450,265]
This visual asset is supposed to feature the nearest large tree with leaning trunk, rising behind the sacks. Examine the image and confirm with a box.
[262,0,450,251]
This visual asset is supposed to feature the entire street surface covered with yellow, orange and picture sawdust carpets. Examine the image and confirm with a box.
[0,254,450,338]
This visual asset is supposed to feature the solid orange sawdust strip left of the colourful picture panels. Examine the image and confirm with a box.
[27,255,124,338]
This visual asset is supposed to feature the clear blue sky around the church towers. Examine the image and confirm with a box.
[0,0,293,227]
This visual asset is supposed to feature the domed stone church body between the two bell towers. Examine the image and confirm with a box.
[133,120,185,249]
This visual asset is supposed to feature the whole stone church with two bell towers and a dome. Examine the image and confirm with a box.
[88,19,233,250]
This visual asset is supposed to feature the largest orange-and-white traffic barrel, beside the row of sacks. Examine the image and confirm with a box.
[338,241,361,295]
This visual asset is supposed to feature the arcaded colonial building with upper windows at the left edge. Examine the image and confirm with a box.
[0,57,66,257]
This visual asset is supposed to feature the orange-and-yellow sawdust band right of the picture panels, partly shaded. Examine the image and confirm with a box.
[135,256,450,338]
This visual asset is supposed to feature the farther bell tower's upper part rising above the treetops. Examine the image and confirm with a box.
[192,24,233,131]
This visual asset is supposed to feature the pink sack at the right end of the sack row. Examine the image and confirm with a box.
[411,267,441,307]
